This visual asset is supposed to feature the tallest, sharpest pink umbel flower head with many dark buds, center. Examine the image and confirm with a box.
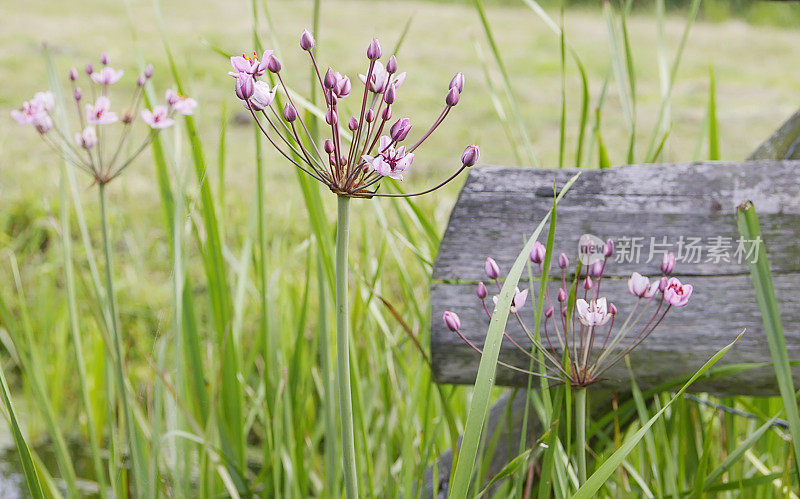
[228,30,480,198]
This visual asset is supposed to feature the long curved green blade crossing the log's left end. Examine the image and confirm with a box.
[449,174,580,499]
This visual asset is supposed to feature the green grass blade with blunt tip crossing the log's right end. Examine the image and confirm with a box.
[736,201,800,486]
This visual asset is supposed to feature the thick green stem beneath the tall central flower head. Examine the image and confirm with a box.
[336,196,358,499]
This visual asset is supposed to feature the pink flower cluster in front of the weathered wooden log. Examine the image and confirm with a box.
[443,239,692,387]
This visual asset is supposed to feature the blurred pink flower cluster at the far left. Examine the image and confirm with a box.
[11,52,197,184]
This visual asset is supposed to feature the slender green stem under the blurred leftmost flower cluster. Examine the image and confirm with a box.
[97,184,145,494]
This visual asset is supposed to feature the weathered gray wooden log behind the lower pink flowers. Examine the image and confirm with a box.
[431,161,800,395]
